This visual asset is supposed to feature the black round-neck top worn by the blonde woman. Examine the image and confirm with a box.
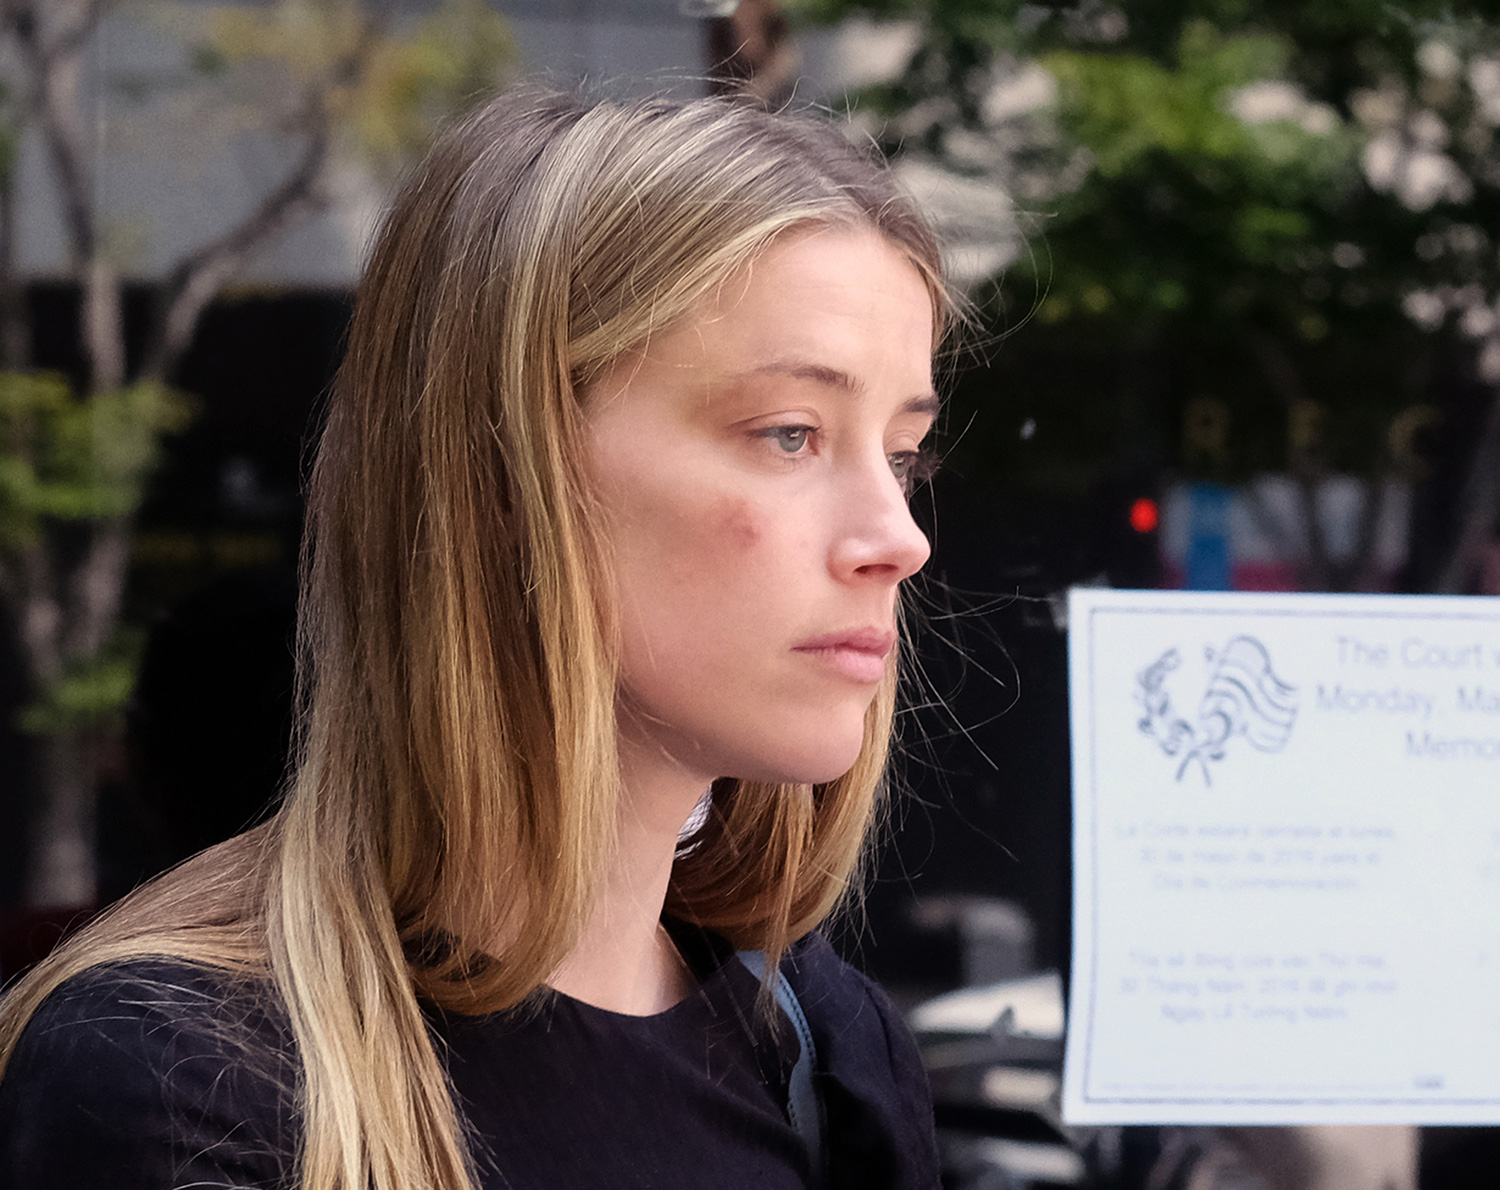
[0,926,938,1190]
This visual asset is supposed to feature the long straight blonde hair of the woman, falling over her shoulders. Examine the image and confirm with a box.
[0,89,944,1190]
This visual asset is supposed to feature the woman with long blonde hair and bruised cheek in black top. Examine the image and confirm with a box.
[0,92,945,1190]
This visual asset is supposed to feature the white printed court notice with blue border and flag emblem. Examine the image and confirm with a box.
[1064,590,1500,1124]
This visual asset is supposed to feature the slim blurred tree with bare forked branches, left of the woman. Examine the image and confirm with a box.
[0,0,513,905]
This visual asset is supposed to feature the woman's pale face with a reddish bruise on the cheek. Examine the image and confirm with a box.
[590,228,938,783]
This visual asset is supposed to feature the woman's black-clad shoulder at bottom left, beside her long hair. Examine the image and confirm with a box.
[0,957,296,1190]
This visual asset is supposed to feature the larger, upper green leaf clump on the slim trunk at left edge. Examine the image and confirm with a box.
[0,372,192,548]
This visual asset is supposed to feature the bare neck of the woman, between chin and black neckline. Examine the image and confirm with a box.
[548,740,705,1016]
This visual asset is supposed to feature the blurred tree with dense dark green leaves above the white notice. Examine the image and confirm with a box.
[800,0,1500,588]
